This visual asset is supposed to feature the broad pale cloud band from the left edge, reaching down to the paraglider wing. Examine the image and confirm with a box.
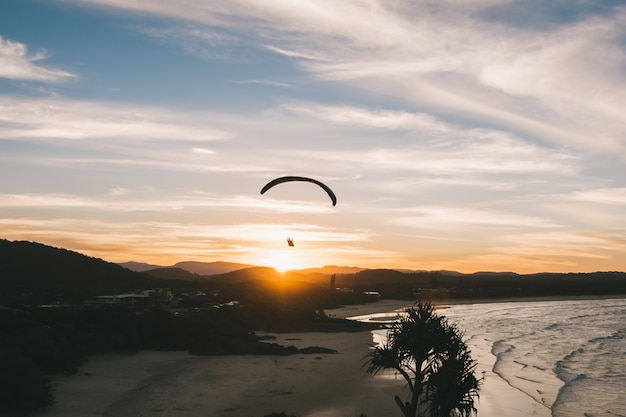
[0,96,582,203]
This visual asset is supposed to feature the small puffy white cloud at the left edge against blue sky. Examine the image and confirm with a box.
[0,36,75,82]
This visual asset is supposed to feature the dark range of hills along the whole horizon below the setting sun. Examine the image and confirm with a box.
[0,239,626,305]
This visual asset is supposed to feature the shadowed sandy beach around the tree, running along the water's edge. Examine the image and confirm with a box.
[35,301,550,417]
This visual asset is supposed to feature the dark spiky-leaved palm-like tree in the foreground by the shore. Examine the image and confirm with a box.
[366,303,480,417]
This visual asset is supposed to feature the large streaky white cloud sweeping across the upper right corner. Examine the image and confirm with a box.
[68,0,626,157]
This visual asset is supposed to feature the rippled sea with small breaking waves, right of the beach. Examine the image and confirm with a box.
[354,299,626,417]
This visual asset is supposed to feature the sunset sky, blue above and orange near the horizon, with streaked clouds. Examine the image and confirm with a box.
[0,0,626,273]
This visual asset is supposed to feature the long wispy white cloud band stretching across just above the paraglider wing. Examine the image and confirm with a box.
[0,96,579,184]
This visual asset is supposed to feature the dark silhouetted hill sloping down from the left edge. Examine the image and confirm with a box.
[0,239,171,304]
